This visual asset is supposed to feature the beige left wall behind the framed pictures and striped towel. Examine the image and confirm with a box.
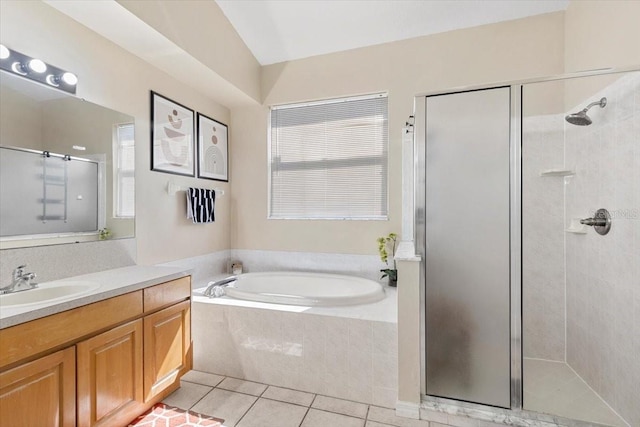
[0,0,231,264]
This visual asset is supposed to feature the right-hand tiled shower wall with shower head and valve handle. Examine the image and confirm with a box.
[565,72,640,425]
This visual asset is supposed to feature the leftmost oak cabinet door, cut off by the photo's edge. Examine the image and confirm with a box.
[0,347,76,427]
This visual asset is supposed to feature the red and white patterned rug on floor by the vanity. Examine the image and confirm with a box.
[129,403,224,427]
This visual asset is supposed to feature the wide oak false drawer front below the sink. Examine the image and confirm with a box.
[0,291,142,367]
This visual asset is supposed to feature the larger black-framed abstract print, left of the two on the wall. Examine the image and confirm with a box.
[151,91,195,176]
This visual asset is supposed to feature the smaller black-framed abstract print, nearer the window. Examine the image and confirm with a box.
[198,113,229,182]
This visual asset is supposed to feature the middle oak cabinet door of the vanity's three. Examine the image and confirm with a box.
[77,319,144,427]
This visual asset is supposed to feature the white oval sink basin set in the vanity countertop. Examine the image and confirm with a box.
[0,280,100,307]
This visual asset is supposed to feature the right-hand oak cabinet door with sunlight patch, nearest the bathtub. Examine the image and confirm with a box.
[144,301,192,401]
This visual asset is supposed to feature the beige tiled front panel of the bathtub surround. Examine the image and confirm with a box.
[191,300,398,408]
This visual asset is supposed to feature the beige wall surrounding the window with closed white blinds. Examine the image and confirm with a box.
[231,12,564,254]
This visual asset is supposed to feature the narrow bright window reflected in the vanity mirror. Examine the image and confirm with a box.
[113,123,135,218]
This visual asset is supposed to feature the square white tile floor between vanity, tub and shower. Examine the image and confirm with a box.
[164,371,439,427]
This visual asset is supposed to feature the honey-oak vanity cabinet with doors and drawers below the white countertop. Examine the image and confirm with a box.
[0,277,192,427]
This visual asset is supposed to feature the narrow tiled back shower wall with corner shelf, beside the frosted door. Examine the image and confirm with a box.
[522,114,565,361]
